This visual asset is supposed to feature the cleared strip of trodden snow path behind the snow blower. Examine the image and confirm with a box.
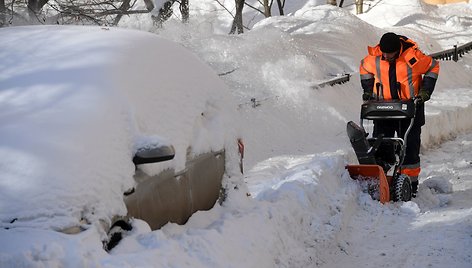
[318,134,472,267]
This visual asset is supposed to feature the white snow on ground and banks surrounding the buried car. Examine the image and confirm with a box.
[0,0,472,267]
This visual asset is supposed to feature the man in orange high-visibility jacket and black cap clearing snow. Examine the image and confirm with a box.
[360,32,439,197]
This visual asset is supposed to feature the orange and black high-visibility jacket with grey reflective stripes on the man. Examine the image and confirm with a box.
[360,36,439,100]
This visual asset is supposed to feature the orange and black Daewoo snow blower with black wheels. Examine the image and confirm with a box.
[346,100,416,204]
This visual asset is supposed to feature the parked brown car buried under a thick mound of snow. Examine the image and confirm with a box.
[0,26,242,249]
